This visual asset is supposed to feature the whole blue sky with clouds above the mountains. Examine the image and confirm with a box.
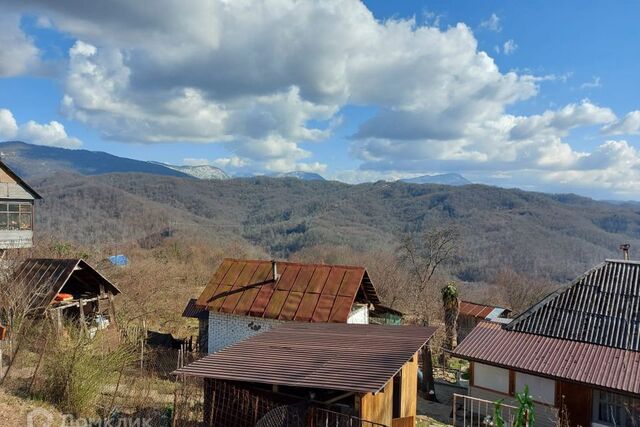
[0,0,640,200]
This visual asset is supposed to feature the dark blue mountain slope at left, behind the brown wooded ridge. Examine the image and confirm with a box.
[0,141,188,179]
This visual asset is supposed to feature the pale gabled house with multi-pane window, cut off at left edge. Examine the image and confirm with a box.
[0,161,42,250]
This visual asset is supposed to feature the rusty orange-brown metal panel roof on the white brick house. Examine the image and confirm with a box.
[197,259,380,322]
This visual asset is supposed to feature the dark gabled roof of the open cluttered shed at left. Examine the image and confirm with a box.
[14,258,120,307]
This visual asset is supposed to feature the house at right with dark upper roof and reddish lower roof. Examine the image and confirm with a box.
[455,260,640,426]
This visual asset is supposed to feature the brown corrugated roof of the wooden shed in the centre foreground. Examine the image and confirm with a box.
[176,322,436,393]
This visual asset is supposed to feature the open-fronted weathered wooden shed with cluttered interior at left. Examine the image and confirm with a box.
[14,259,120,334]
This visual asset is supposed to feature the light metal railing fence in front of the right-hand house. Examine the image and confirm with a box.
[453,393,518,427]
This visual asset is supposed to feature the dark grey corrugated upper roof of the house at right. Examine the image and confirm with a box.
[506,260,640,351]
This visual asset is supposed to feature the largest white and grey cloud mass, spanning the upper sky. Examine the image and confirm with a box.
[5,0,537,174]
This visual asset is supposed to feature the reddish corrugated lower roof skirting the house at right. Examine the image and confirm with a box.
[454,322,640,394]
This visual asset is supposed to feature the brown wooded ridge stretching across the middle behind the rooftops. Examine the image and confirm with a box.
[31,174,640,281]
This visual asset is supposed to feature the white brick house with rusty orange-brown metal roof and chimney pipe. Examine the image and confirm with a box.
[196,259,380,353]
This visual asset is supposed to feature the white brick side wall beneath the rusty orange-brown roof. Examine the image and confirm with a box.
[208,311,283,353]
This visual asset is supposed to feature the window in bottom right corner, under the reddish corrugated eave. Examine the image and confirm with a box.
[593,390,640,427]
